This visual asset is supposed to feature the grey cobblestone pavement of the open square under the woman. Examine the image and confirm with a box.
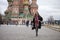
[0,25,60,40]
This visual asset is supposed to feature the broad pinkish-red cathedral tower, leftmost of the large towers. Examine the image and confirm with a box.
[11,0,19,18]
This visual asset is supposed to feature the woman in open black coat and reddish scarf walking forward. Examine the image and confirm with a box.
[32,13,43,36]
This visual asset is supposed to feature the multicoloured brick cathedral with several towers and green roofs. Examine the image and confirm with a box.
[5,0,38,22]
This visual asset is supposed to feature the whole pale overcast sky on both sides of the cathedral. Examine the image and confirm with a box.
[0,0,60,20]
